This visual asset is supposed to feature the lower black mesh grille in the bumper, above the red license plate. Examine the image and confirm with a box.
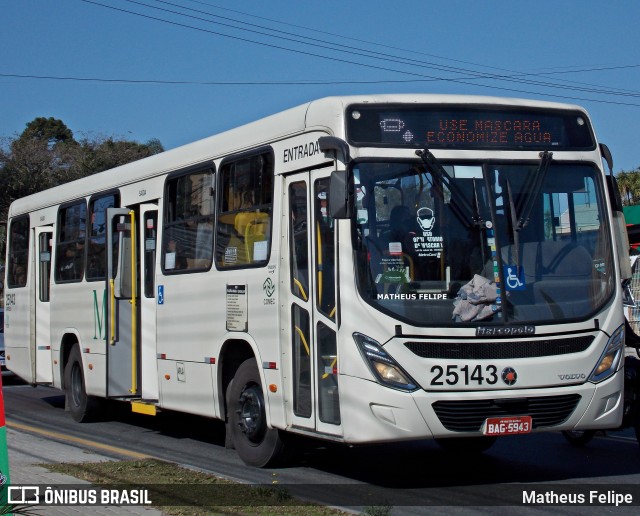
[432,394,581,432]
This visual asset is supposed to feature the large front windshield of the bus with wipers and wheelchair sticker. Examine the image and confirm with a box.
[354,160,615,326]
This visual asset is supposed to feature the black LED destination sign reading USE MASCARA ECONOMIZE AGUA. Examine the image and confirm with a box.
[347,105,595,150]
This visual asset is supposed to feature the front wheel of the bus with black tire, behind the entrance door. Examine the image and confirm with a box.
[227,359,284,468]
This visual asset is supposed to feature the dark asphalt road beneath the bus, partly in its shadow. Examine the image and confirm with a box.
[3,376,640,514]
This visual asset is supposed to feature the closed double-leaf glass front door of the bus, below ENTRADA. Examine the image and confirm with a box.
[281,169,342,435]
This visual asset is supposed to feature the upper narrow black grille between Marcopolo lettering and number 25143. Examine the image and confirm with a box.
[405,335,594,360]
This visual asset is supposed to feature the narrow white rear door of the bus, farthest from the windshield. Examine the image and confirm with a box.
[34,226,53,384]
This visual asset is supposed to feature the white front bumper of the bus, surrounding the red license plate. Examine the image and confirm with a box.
[340,371,624,444]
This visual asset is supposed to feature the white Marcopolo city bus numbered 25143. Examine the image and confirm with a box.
[5,95,629,466]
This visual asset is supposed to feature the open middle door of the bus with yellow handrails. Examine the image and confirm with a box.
[106,204,158,400]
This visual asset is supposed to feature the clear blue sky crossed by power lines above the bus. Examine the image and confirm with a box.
[0,0,640,172]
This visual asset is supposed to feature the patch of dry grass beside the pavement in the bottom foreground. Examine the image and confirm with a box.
[43,459,347,516]
